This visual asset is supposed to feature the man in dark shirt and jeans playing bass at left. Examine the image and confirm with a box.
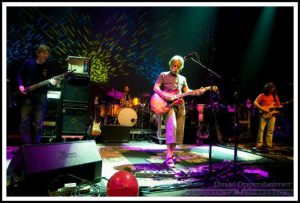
[17,44,57,144]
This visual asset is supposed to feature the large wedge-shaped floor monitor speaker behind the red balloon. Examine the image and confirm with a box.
[22,140,102,196]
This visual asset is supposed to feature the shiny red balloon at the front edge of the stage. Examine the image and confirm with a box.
[107,171,139,196]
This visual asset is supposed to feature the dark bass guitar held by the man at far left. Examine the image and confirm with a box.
[13,70,74,106]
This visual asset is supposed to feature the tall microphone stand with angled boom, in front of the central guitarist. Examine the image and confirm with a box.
[190,58,221,177]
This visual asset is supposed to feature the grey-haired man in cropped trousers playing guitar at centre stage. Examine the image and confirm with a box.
[153,55,203,167]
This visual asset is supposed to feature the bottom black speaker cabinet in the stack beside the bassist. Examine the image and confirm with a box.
[61,104,88,135]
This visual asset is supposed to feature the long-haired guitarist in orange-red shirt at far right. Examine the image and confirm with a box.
[254,82,282,148]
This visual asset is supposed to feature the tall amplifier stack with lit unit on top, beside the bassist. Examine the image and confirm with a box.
[60,56,90,139]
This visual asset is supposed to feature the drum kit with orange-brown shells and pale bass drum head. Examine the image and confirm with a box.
[99,89,150,127]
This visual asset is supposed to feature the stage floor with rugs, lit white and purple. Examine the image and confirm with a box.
[6,140,294,197]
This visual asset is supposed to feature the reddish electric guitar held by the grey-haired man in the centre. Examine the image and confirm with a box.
[150,86,218,114]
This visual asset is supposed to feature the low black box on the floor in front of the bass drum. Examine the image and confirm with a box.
[96,125,130,143]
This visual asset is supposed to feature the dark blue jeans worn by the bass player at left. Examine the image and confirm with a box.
[20,94,47,144]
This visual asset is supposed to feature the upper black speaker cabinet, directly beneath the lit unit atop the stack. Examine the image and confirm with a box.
[62,76,89,103]
